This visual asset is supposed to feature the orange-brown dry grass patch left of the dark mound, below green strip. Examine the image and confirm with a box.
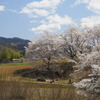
[0,64,32,80]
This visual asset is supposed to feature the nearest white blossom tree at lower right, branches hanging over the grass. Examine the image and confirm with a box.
[74,52,100,94]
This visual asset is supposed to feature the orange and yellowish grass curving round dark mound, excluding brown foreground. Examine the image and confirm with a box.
[0,63,71,88]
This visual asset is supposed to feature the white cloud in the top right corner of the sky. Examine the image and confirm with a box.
[75,0,100,14]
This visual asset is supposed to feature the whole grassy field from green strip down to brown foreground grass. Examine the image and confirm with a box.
[0,63,98,100]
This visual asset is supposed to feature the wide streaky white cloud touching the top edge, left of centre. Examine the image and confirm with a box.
[20,0,63,17]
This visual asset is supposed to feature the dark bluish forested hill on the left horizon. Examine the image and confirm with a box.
[0,37,30,55]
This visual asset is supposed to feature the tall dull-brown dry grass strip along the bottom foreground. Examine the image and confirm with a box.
[0,81,84,100]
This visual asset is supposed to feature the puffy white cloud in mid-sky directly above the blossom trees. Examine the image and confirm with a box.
[32,14,73,32]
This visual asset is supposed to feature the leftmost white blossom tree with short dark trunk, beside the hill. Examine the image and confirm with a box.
[26,32,59,68]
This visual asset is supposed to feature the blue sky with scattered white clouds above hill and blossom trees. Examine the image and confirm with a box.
[0,0,100,40]
